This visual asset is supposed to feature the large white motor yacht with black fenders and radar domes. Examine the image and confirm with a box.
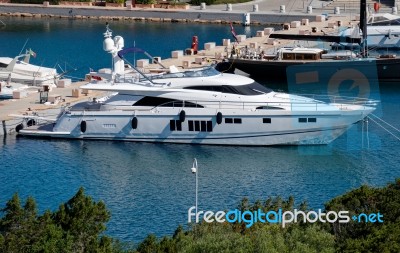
[16,25,375,146]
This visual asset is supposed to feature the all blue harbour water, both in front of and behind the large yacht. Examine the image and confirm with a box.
[0,18,400,241]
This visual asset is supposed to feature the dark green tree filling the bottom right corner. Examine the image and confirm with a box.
[325,179,400,252]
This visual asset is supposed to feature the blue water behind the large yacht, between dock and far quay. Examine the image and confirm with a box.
[0,17,257,78]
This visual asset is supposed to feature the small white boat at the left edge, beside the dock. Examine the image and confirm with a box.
[0,53,58,87]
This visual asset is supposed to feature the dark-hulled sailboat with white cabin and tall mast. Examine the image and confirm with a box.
[224,0,400,85]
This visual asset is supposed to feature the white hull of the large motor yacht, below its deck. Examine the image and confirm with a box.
[19,108,365,146]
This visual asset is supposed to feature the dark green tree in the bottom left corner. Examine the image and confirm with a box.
[0,188,119,253]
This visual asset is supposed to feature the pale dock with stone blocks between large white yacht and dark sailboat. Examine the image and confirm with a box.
[143,15,359,69]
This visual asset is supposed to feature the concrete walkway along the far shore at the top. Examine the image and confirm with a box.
[0,0,355,24]
